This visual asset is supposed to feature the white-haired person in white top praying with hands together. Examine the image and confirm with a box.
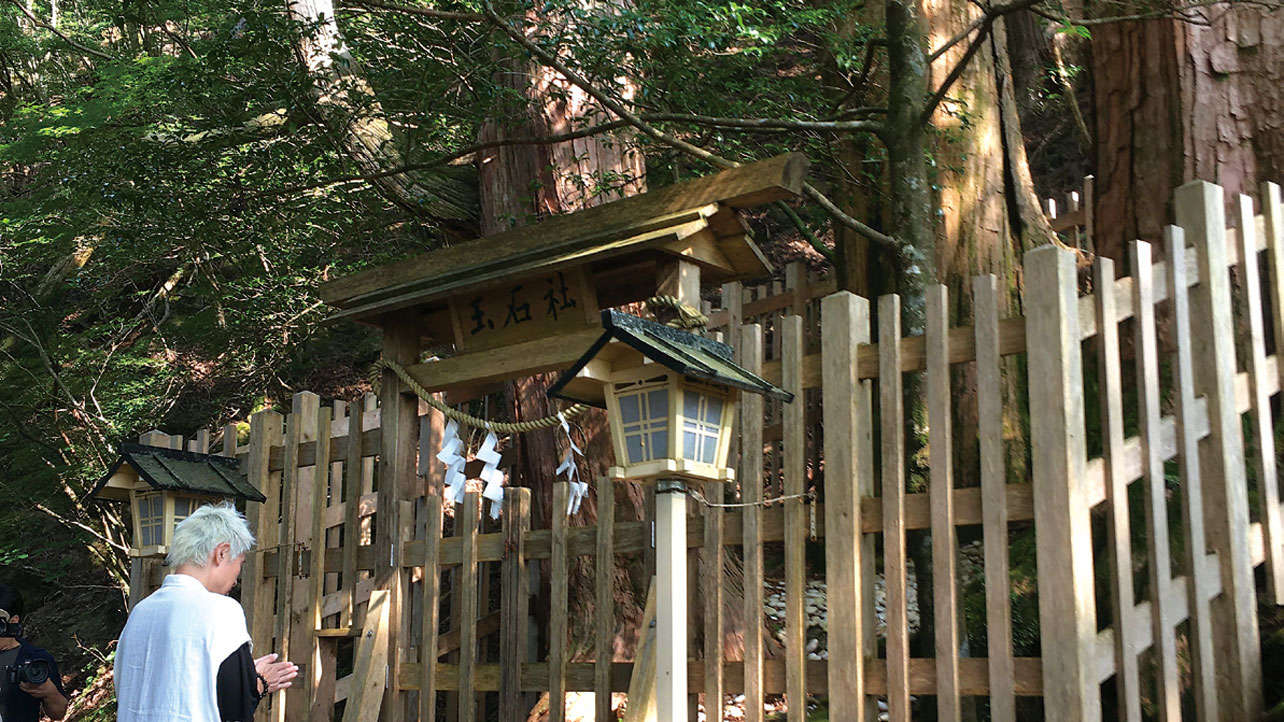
[116,502,299,722]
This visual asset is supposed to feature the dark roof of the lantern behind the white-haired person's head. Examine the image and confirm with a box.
[90,443,267,502]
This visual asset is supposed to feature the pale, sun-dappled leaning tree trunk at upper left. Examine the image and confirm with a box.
[286,0,478,226]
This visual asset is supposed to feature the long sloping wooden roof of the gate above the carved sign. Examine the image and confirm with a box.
[320,153,808,324]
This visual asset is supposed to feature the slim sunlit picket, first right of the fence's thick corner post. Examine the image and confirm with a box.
[1093,257,1154,722]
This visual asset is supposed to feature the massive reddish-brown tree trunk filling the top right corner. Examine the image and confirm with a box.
[1091,5,1284,262]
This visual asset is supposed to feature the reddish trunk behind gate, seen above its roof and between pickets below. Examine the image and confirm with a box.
[478,14,648,693]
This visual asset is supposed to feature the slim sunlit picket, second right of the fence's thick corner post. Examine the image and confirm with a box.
[1131,240,1181,722]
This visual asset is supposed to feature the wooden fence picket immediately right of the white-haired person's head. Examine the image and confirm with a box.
[241,410,285,654]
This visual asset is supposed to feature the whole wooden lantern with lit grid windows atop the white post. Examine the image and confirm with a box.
[548,310,794,482]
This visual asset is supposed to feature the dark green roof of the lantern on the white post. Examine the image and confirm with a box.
[548,308,794,407]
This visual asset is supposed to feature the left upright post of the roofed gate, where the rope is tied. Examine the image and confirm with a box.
[375,317,421,722]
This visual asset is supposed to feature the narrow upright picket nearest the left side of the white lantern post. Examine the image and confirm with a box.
[593,477,615,722]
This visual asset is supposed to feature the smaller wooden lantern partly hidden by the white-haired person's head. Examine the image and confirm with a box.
[91,443,266,556]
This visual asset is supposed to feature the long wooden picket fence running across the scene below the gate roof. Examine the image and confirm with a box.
[132,176,1284,722]
